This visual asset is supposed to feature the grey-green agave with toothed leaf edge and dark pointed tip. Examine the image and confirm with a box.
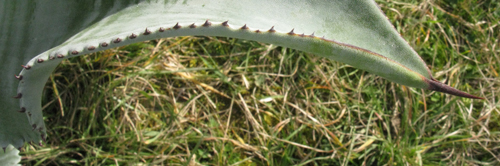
[0,0,479,163]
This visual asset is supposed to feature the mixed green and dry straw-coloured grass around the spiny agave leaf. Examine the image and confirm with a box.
[22,0,500,165]
